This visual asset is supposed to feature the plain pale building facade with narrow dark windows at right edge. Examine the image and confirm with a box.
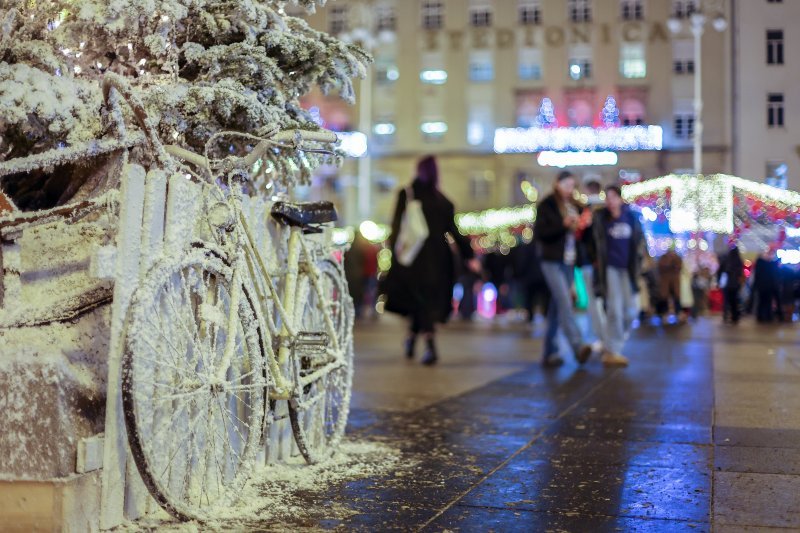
[731,0,800,191]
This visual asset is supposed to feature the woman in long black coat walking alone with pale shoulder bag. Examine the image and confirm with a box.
[382,156,476,365]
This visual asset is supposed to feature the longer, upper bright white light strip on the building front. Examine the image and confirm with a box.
[494,126,663,154]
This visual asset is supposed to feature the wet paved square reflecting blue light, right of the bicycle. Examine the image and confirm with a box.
[272,319,800,532]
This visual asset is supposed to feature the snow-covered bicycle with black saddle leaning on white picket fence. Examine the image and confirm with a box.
[104,75,353,520]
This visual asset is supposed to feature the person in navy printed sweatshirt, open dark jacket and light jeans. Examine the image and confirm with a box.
[592,185,644,366]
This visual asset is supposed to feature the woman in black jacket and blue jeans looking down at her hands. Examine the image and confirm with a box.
[534,171,592,367]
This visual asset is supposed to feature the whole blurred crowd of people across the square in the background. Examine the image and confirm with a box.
[345,158,800,366]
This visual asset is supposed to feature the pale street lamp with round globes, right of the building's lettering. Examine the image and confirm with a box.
[667,0,728,175]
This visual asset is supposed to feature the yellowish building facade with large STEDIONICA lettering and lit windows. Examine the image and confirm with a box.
[298,0,732,221]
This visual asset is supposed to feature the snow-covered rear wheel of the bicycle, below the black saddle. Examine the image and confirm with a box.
[289,260,354,464]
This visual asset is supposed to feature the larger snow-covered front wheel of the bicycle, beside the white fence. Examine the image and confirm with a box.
[122,249,267,520]
